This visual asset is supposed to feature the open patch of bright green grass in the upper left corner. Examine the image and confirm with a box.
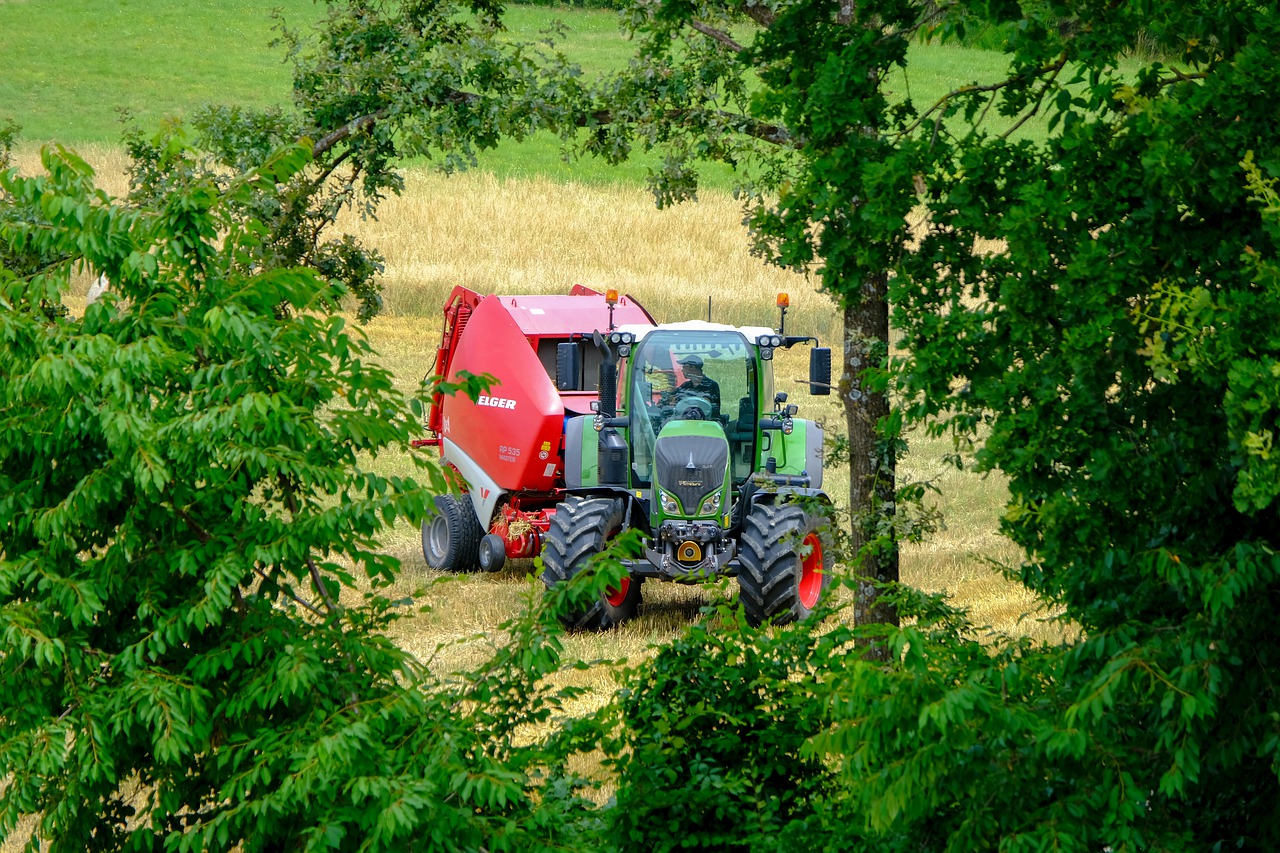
[0,0,323,145]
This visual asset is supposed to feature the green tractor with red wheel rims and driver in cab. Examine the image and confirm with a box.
[541,298,835,630]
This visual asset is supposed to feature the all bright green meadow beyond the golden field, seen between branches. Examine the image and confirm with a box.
[0,0,1080,190]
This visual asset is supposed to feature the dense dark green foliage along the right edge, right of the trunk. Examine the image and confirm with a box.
[893,3,1280,849]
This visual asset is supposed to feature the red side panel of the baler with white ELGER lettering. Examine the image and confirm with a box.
[440,296,565,491]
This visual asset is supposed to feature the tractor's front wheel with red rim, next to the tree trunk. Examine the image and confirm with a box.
[737,503,835,625]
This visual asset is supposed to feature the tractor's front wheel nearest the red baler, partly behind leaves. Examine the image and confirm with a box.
[541,498,640,631]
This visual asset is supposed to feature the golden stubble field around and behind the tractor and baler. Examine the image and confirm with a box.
[18,147,1056,688]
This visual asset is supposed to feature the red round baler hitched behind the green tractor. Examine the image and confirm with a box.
[413,284,654,571]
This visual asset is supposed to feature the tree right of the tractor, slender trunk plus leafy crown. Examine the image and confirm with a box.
[584,0,928,637]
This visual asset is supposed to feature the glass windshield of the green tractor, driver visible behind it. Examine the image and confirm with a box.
[627,329,759,485]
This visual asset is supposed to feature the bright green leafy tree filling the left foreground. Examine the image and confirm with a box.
[0,145,599,850]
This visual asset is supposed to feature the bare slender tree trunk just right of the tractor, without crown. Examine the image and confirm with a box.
[840,273,899,650]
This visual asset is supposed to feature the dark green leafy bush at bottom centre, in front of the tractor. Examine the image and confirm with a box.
[608,606,847,850]
